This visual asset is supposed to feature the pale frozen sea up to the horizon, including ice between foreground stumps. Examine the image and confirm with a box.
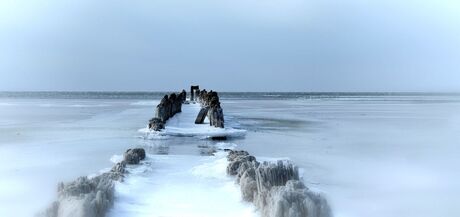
[0,92,460,217]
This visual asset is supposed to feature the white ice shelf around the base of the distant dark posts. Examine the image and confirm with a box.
[139,104,246,139]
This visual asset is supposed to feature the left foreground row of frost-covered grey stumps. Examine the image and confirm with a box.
[41,148,145,217]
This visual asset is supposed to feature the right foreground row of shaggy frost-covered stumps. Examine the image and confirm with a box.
[227,150,331,217]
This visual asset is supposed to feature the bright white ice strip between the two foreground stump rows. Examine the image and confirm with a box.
[108,152,258,217]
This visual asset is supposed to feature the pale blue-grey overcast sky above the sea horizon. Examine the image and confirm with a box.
[0,0,460,92]
